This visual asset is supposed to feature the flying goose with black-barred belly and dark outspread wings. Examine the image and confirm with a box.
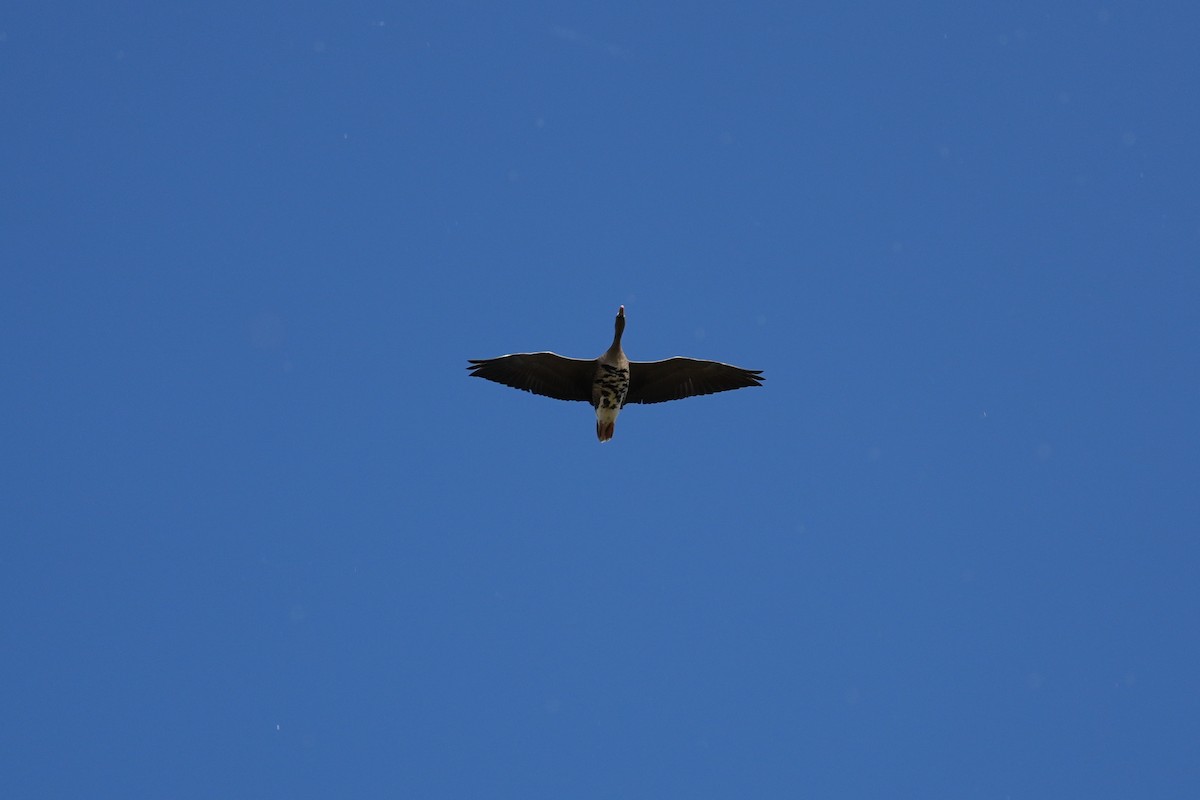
[467,306,764,441]
